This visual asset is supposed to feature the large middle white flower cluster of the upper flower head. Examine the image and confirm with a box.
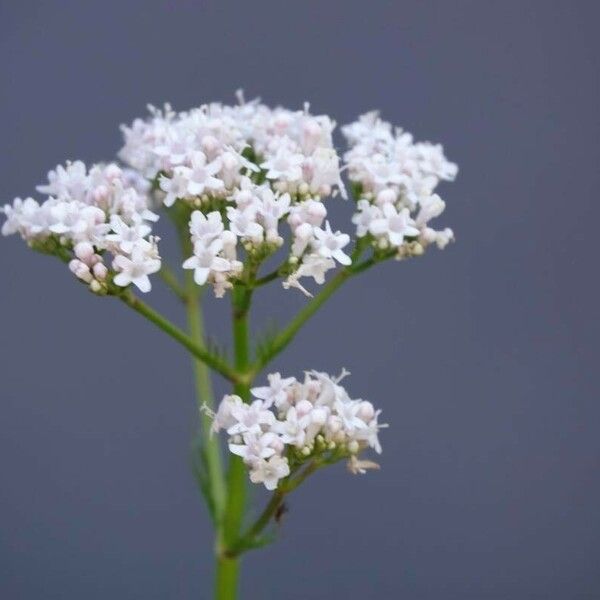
[119,99,350,296]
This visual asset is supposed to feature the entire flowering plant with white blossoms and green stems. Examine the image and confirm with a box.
[1,93,457,599]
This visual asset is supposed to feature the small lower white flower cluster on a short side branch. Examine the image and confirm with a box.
[213,371,385,490]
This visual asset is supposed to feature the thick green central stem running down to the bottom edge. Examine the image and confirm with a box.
[215,284,252,600]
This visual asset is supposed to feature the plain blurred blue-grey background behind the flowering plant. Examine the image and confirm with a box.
[0,0,600,600]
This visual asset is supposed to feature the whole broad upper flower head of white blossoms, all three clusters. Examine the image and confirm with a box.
[2,93,457,297]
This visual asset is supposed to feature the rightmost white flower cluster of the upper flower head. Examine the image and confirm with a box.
[342,112,458,256]
